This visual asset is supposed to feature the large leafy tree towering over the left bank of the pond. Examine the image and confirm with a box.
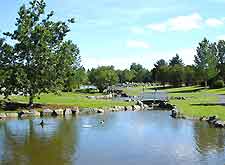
[0,0,79,104]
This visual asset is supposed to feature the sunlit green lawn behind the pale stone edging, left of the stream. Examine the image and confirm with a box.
[1,92,133,111]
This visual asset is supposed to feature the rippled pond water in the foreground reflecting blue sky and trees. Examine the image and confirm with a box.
[0,111,225,165]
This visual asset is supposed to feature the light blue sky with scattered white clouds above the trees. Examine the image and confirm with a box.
[0,0,225,69]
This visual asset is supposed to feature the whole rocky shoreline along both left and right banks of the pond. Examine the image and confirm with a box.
[0,101,225,128]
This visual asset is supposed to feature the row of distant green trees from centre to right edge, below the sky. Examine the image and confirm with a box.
[67,38,225,91]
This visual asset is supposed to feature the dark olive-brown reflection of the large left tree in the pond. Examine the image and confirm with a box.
[0,119,78,165]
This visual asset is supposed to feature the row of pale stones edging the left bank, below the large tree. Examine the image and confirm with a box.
[0,102,148,119]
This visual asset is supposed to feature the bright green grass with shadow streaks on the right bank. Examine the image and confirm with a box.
[165,86,225,120]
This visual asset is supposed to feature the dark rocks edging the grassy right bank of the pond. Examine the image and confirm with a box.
[170,106,225,128]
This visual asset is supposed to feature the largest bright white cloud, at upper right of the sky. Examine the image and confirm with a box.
[146,13,203,32]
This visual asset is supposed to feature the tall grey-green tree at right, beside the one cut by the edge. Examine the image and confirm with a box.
[194,38,218,86]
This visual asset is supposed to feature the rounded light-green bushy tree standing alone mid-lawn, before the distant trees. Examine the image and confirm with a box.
[88,66,119,93]
